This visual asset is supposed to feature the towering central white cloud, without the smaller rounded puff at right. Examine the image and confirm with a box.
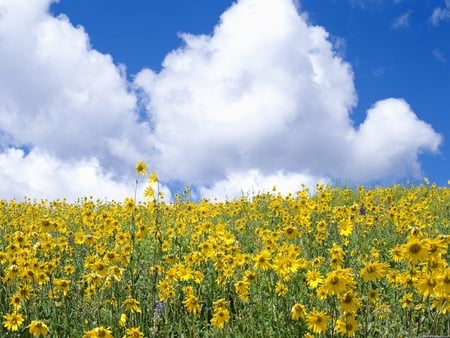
[136,0,356,184]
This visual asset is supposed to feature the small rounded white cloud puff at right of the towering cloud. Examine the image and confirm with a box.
[350,98,442,181]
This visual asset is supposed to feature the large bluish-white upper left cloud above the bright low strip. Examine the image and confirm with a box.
[0,0,153,171]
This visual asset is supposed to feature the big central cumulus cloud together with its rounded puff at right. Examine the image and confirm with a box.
[135,0,441,195]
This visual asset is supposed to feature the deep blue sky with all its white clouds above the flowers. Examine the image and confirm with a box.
[0,0,450,200]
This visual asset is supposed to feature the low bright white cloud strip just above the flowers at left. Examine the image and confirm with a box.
[0,148,134,201]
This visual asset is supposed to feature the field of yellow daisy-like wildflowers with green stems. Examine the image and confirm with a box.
[0,162,450,338]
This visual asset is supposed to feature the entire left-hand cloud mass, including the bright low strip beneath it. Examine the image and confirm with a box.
[0,0,153,198]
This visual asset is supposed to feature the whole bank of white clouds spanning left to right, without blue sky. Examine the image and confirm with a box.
[0,0,441,198]
